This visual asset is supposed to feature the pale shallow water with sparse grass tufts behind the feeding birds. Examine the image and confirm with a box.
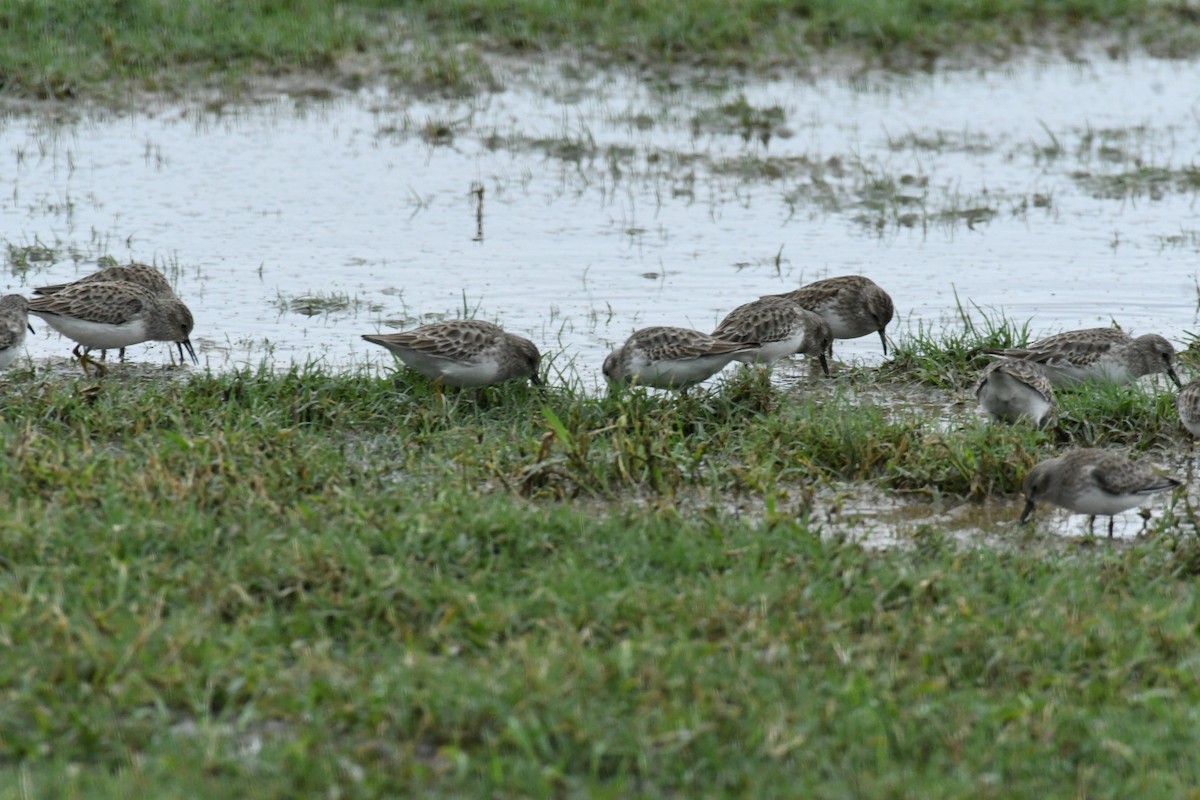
[0,51,1200,386]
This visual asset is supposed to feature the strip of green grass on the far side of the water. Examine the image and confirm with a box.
[7,0,1200,98]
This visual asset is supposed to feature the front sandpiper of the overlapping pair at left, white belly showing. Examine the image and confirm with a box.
[29,281,197,372]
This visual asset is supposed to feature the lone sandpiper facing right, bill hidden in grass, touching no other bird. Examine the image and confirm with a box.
[362,319,542,387]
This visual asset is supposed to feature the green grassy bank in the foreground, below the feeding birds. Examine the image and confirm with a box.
[0,352,1200,798]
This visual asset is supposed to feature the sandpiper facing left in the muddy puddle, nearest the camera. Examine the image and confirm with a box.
[1020,447,1181,537]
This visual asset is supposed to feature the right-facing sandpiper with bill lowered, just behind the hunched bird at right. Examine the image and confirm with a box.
[984,327,1181,386]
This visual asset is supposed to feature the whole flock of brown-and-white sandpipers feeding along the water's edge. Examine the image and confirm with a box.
[0,264,1200,536]
